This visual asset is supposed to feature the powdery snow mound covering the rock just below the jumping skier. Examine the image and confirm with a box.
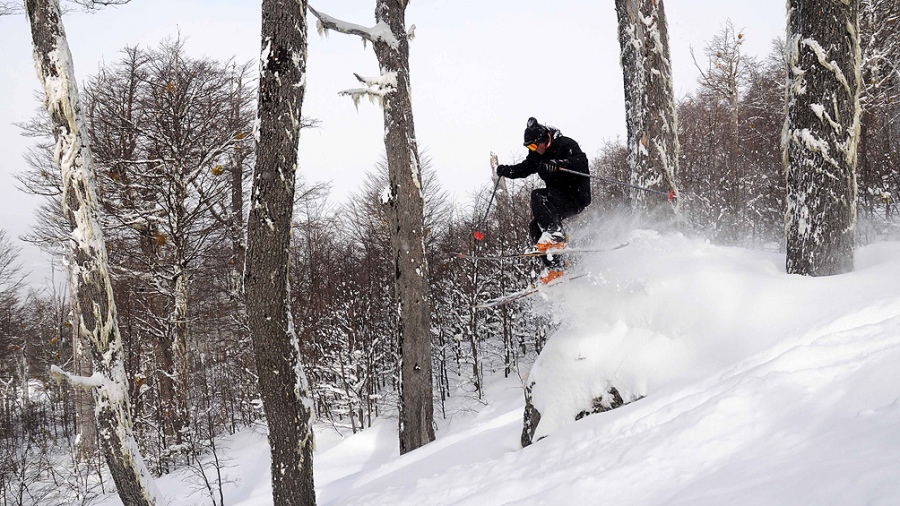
[528,230,893,440]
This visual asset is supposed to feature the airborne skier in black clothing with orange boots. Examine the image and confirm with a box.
[497,118,591,284]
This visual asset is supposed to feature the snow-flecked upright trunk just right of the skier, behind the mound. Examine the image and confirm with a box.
[616,0,679,211]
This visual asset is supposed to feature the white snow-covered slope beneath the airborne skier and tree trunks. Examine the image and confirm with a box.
[96,231,900,506]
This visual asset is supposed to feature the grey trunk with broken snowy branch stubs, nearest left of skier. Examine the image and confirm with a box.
[374,0,434,453]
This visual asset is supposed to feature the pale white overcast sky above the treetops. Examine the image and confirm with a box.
[0,0,785,283]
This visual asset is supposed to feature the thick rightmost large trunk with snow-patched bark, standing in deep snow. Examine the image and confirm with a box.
[782,0,861,276]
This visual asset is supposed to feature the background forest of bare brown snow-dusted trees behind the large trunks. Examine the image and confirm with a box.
[0,0,900,506]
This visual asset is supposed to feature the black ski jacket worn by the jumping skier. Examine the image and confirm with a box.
[507,128,591,209]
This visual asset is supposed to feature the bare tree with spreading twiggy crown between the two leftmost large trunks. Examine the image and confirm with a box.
[85,39,251,454]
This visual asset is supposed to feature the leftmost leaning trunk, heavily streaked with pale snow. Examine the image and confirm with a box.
[25,0,158,506]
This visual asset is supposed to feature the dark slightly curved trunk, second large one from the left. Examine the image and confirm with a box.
[244,0,316,506]
